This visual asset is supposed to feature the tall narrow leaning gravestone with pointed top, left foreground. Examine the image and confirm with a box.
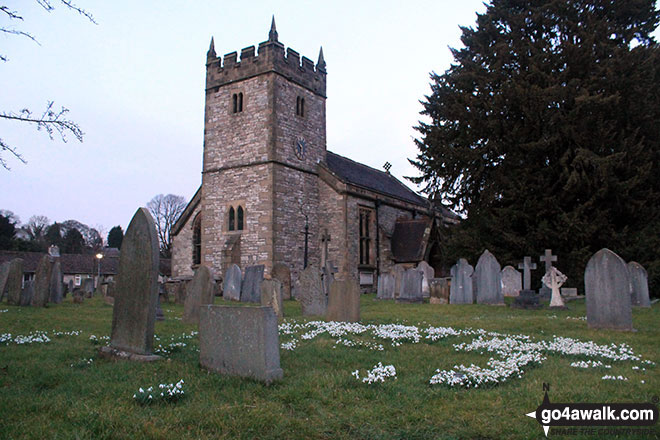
[100,208,160,362]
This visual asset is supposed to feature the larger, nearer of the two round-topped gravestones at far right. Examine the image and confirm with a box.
[584,249,633,331]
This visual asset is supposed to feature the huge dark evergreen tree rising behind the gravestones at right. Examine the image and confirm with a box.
[412,0,660,294]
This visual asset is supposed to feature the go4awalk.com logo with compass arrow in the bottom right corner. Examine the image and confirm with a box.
[526,383,658,437]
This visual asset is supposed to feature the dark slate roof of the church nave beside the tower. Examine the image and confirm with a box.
[325,151,428,208]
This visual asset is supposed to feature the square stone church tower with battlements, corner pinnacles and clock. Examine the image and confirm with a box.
[200,19,326,274]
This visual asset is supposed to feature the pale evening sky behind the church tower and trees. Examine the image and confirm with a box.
[0,0,516,238]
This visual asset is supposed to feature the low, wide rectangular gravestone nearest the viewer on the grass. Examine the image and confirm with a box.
[199,305,284,383]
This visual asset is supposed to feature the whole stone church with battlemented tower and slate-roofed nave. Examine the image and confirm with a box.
[172,19,458,291]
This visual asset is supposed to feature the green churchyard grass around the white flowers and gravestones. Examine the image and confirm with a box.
[0,295,660,439]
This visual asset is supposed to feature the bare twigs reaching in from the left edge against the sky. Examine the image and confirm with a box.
[0,0,96,170]
